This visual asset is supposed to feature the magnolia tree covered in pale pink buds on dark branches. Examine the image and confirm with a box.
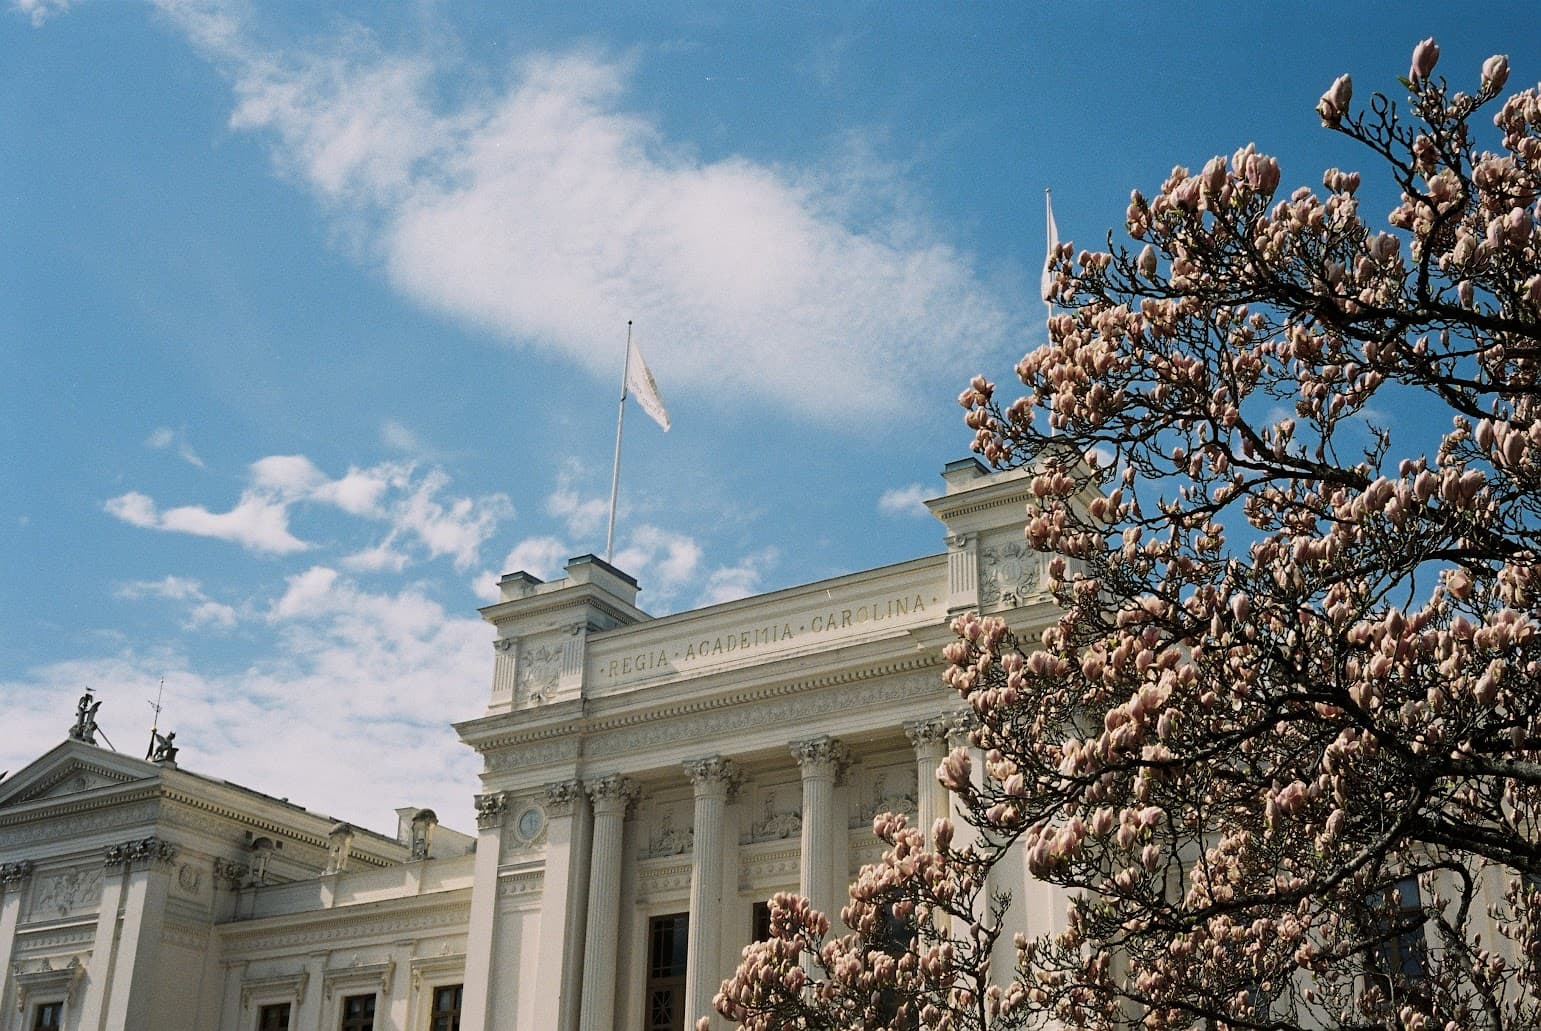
[717,40,1541,1029]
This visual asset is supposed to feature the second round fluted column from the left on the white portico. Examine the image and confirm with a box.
[684,755,738,1028]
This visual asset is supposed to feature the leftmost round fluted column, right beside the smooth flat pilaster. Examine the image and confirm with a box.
[578,775,640,1031]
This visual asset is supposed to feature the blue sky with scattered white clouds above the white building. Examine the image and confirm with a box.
[0,0,1541,829]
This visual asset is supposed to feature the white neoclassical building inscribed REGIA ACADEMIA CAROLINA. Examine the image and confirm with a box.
[0,459,1056,1031]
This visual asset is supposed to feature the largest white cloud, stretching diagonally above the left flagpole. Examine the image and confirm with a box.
[153,10,1023,419]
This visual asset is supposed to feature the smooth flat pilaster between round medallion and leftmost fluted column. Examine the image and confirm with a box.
[529,780,590,1031]
